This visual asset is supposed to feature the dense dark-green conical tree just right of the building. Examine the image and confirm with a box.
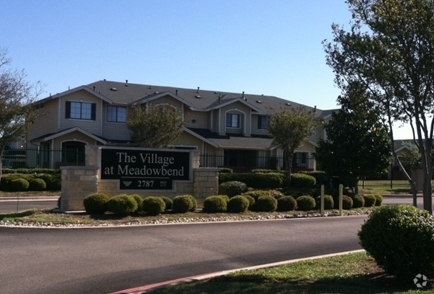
[315,85,391,194]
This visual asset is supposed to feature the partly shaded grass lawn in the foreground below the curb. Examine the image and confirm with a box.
[148,252,434,294]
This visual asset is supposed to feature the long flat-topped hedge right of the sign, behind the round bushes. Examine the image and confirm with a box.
[219,172,285,189]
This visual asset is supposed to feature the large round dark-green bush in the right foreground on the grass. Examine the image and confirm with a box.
[358,205,434,282]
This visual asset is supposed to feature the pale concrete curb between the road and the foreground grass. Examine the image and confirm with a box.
[109,249,365,294]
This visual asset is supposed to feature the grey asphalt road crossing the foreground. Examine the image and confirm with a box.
[0,216,366,294]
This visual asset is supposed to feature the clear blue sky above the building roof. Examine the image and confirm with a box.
[0,0,412,139]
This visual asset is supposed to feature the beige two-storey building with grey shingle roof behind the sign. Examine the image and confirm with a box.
[26,80,332,170]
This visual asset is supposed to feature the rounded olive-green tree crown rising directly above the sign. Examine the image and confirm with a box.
[127,104,185,148]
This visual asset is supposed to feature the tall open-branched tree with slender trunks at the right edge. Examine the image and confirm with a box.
[323,0,434,213]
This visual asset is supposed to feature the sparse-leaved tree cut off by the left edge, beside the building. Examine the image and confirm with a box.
[0,48,42,179]
